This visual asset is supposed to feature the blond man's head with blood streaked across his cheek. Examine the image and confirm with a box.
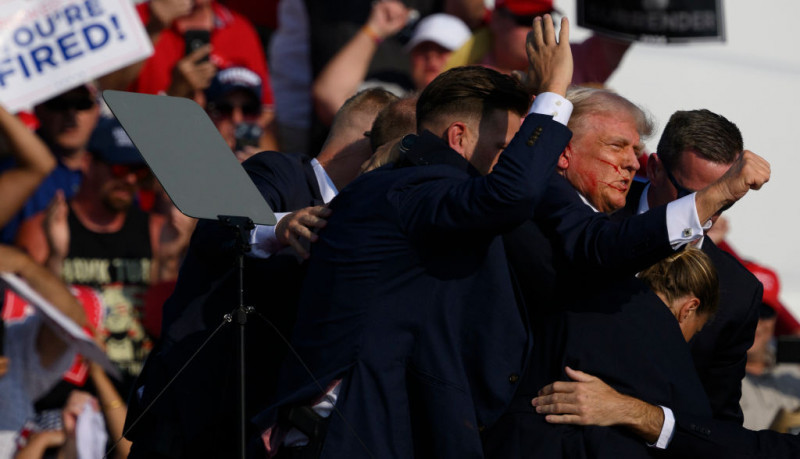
[558,88,653,213]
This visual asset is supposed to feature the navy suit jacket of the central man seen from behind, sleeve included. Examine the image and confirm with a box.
[253,115,570,458]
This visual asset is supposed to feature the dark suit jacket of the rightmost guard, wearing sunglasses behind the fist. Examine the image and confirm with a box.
[612,182,763,424]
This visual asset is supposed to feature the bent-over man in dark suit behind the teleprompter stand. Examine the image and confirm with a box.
[128,89,397,458]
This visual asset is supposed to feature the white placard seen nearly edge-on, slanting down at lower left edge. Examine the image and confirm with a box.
[0,272,120,379]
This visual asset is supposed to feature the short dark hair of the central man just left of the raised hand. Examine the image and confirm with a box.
[417,65,531,131]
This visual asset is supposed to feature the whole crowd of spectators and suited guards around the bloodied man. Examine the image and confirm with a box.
[0,0,800,459]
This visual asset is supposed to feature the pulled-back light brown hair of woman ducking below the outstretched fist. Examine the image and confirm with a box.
[639,247,719,316]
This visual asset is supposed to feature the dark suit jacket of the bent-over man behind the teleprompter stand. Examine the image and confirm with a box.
[128,152,322,457]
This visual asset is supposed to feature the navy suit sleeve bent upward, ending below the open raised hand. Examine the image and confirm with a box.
[389,114,572,237]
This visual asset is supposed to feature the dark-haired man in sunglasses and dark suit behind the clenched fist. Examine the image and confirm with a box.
[612,110,762,424]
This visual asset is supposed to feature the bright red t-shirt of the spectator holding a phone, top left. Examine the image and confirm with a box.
[130,2,274,105]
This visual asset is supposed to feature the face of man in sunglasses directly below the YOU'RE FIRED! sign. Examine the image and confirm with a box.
[36,89,100,153]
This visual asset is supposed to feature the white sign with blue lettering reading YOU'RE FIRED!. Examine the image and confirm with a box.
[0,0,153,111]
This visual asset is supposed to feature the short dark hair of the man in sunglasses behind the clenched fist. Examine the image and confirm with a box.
[656,109,744,169]
